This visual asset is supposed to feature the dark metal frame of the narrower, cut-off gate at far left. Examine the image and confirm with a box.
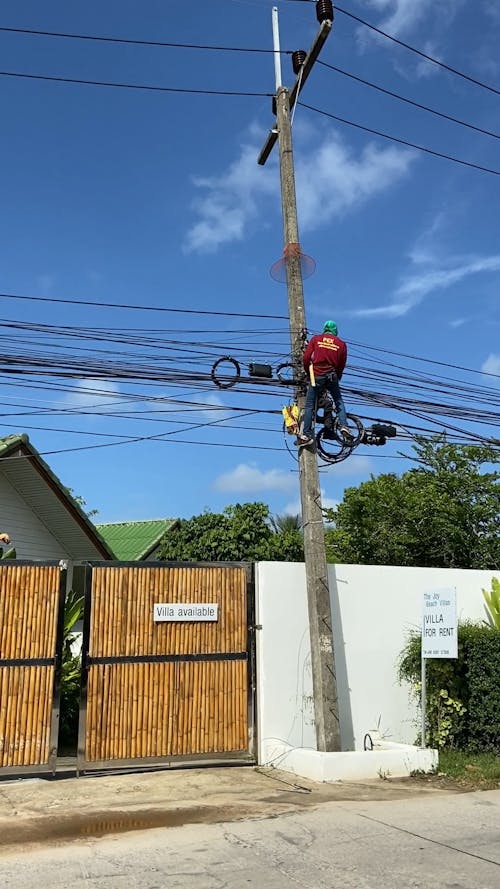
[0,559,68,778]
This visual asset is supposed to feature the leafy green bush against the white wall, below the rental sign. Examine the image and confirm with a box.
[399,623,500,753]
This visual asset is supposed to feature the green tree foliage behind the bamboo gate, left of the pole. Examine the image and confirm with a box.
[159,503,304,562]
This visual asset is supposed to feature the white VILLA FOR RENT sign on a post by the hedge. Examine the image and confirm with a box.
[422,589,458,658]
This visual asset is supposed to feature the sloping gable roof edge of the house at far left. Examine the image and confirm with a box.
[0,434,115,559]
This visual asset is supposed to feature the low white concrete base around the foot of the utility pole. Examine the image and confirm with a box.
[261,741,438,782]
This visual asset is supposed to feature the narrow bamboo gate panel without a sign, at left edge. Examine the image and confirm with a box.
[0,561,66,774]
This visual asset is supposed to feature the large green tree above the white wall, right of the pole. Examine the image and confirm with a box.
[326,436,500,569]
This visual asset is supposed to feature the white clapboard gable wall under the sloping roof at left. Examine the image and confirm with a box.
[0,471,68,560]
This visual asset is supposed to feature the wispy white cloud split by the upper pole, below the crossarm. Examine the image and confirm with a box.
[184,126,416,253]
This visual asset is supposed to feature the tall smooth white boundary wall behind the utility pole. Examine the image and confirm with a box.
[256,562,500,762]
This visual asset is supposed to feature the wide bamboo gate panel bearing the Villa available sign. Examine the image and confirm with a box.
[78,562,255,771]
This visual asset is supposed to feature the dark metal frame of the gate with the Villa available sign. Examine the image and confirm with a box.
[78,561,257,775]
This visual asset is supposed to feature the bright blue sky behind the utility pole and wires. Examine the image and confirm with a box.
[0,0,500,521]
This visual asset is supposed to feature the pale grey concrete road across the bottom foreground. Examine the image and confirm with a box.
[0,791,500,889]
